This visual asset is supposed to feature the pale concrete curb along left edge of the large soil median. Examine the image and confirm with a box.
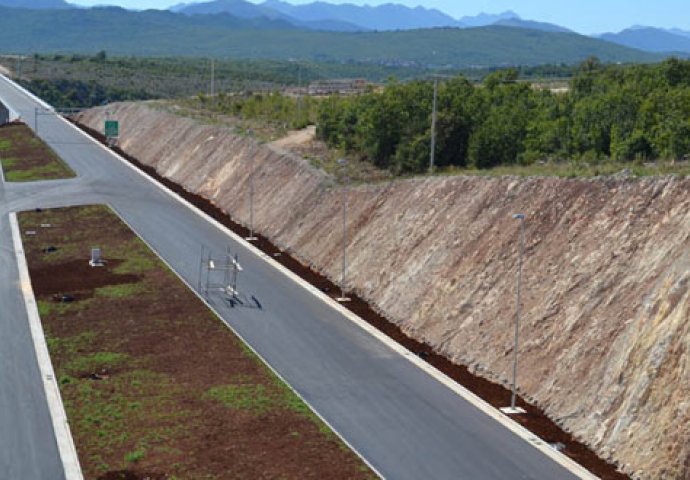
[10,213,84,480]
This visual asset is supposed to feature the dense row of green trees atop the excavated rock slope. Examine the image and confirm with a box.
[317,59,690,173]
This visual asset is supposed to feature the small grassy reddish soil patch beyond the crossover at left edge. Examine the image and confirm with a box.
[0,122,74,181]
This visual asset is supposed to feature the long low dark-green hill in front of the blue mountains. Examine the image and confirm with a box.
[0,8,660,67]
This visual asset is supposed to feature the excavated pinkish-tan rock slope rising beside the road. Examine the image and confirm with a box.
[82,104,690,479]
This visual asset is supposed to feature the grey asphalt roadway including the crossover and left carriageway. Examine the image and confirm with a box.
[0,78,577,480]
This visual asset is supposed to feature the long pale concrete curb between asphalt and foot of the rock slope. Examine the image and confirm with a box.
[2,75,598,480]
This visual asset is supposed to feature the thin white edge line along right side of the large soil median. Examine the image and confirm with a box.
[107,204,386,479]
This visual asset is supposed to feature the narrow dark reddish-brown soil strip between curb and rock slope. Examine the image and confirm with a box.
[77,124,629,480]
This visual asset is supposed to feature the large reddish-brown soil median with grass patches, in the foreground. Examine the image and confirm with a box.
[20,207,372,480]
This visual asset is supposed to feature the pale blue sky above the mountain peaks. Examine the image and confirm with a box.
[68,0,690,34]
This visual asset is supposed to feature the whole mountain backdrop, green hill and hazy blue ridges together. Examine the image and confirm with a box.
[0,0,690,62]
